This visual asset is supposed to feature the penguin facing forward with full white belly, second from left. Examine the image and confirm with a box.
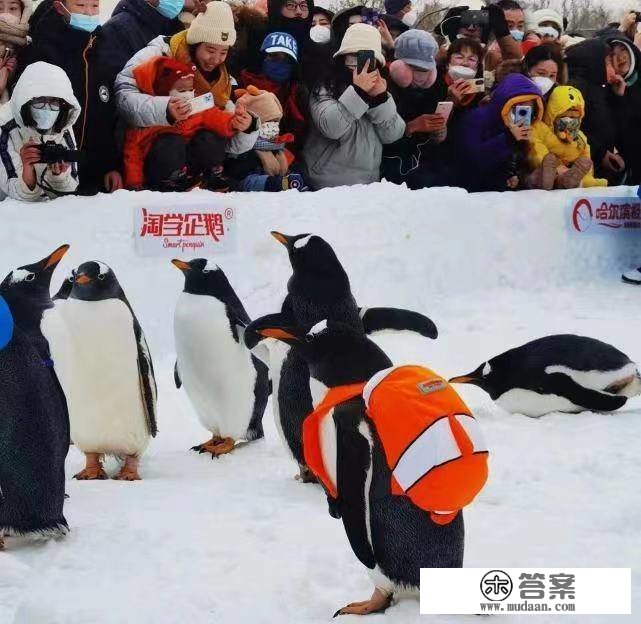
[52,262,157,481]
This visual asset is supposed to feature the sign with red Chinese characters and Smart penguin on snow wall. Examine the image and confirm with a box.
[134,204,236,258]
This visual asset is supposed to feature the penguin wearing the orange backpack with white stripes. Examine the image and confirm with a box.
[247,321,487,615]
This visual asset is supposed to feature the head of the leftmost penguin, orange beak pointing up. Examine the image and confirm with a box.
[0,245,69,317]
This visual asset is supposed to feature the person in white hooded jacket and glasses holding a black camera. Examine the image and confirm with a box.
[0,62,80,202]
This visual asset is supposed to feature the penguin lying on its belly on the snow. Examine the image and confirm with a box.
[450,334,641,417]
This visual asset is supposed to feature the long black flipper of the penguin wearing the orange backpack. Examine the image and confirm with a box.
[329,399,376,570]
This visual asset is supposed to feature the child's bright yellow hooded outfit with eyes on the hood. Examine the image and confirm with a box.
[528,87,608,187]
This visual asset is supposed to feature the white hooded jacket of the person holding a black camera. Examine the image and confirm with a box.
[0,61,80,202]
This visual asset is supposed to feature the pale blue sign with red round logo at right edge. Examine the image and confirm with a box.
[571,197,641,234]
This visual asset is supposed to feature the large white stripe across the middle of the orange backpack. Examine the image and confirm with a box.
[394,417,461,491]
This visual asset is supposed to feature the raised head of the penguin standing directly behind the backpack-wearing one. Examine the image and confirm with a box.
[271,232,349,295]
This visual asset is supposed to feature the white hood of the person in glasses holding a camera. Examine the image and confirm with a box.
[9,61,80,130]
